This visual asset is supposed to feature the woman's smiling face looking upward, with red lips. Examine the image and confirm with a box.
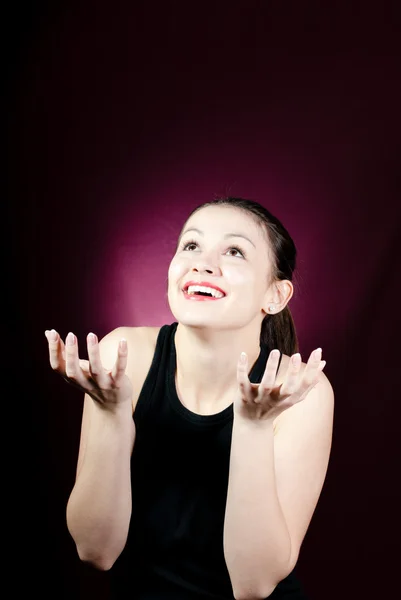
[168,206,272,329]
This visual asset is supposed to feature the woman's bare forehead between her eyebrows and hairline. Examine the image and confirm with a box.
[183,206,263,243]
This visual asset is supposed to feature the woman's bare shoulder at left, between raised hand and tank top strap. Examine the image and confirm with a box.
[118,327,160,412]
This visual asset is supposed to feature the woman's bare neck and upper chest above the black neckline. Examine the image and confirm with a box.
[175,323,260,414]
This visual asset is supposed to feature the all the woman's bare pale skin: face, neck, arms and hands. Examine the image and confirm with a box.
[46,207,334,599]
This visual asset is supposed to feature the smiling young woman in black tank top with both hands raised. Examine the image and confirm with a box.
[46,198,334,600]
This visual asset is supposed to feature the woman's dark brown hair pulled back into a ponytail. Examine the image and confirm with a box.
[177,196,299,356]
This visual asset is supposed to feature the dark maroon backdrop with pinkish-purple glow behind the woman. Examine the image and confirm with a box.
[5,0,401,600]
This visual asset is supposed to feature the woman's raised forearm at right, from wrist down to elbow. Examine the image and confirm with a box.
[224,416,291,598]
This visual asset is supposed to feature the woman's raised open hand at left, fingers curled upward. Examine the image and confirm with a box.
[45,329,133,410]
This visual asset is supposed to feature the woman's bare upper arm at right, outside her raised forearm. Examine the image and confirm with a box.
[274,373,334,572]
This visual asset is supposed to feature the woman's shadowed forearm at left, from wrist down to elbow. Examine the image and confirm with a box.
[67,405,135,569]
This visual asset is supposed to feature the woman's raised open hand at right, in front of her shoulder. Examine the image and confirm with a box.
[234,348,326,421]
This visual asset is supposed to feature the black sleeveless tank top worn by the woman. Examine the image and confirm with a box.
[110,322,306,600]
